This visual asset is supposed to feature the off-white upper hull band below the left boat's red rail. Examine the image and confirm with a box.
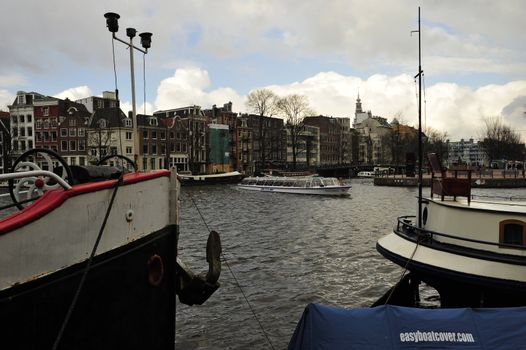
[0,177,170,290]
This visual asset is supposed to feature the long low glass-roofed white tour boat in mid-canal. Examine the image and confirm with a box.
[238,176,351,196]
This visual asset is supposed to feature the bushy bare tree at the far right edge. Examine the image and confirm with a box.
[481,117,524,163]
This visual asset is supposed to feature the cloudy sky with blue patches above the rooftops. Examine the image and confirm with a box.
[0,0,526,141]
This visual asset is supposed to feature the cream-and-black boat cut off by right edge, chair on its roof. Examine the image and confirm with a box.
[377,154,526,307]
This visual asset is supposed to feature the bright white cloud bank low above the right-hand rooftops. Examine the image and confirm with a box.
[260,72,526,141]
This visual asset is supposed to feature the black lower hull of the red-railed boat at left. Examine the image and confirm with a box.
[0,225,178,349]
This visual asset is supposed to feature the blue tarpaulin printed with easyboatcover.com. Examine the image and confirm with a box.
[289,304,526,350]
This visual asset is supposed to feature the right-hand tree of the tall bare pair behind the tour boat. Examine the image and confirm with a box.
[277,94,315,170]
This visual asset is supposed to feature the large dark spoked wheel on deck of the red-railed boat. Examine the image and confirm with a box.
[8,148,73,210]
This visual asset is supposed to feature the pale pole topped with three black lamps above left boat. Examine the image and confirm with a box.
[104,12,152,170]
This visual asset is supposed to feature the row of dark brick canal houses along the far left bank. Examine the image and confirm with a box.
[0,91,376,174]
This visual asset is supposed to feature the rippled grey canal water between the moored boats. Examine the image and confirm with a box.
[176,179,526,349]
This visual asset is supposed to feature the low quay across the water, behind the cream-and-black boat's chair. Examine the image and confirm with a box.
[374,170,526,188]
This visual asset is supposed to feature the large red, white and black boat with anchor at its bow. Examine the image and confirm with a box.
[0,149,220,349]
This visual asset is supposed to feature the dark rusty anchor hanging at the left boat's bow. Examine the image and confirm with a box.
[175,231,221,306]
